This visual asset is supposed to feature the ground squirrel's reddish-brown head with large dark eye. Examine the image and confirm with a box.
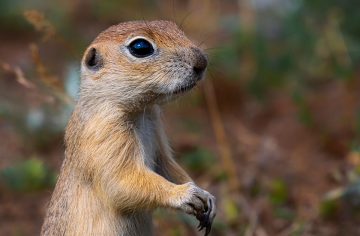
[80,21,207,110]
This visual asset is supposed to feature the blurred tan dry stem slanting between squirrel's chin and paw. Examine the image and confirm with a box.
[204,81,240,191]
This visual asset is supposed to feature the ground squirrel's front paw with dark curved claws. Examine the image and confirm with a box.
[180,183,216,235]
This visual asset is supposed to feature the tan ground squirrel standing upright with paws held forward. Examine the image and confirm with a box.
[41,21,215,236]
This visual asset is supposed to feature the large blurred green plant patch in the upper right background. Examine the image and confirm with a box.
[210,0,360,104]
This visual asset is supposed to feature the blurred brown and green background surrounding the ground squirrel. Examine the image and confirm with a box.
[0,0,360,236]
